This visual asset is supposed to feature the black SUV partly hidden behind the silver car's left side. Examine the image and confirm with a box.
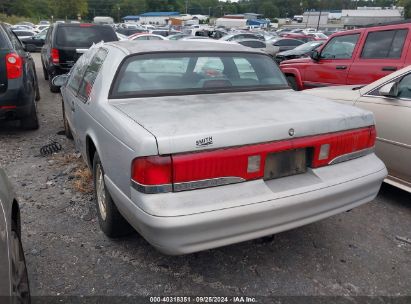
[41,23,118,93]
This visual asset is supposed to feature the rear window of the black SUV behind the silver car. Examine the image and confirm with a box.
[56,25,118,48]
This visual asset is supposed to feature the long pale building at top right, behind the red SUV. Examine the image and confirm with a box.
[341,7,404,29]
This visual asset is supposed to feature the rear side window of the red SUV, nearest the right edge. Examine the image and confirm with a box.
[361,29,408,59]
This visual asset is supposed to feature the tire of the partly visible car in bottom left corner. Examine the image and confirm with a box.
[10,223,31,304]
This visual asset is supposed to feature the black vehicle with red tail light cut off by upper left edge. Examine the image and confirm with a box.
[0,23,40,130]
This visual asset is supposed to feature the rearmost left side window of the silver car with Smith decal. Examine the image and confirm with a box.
[78,48,107,101]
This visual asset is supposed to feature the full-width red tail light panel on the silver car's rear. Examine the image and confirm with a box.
[131,126,376,193]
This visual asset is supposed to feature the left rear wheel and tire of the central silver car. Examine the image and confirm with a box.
[93,152,133,238]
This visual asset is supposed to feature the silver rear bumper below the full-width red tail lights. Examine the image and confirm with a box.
[106,154,387,255]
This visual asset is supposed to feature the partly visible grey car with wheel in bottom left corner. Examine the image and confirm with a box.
[0,169,30,304]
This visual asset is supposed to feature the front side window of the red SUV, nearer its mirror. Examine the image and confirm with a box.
[321,34,360,59]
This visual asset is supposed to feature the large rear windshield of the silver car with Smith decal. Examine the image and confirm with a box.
[110,52,288,98]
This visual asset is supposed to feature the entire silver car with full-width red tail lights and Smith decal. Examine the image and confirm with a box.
[53,41,387,254]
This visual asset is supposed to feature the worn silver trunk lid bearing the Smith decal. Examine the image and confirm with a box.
[111,90,374,154]
